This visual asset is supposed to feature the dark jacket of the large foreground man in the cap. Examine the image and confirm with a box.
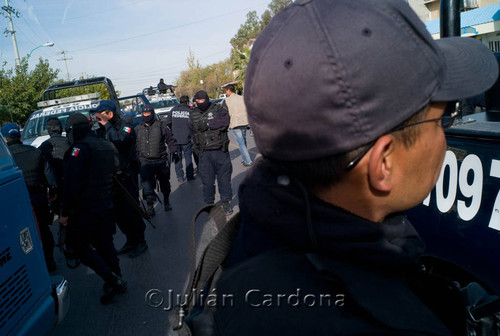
[192,160,464,335]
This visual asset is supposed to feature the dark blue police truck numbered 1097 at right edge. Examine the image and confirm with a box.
[408,1,500,295]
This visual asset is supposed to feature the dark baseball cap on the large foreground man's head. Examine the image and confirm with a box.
[244,0,498,161]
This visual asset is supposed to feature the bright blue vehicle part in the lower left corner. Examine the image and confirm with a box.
[0,137,69,336]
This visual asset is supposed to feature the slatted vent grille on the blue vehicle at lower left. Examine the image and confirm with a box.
[0,265,33,331]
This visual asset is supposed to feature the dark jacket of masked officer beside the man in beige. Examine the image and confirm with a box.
[189,104,229,152]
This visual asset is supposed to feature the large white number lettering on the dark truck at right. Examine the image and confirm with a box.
[423,150,500,231]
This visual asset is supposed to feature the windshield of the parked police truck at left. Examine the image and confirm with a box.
[22,103,92,140]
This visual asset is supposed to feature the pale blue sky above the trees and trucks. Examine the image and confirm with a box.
[0,0,271,97]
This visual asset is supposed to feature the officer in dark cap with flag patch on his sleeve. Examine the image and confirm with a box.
[90,100,148,258]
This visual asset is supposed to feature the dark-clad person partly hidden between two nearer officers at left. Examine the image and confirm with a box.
[38,117,70,214]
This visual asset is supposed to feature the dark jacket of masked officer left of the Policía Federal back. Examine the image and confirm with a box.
[134,120,177,163]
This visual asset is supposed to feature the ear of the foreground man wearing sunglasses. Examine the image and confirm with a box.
[368,135,395,192]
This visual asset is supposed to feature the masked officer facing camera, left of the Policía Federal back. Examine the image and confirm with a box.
[134,105,179,216]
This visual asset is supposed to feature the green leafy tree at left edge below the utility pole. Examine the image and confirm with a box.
[0,58,59,125]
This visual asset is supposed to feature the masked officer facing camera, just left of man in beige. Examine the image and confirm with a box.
[189,90,233,215]
